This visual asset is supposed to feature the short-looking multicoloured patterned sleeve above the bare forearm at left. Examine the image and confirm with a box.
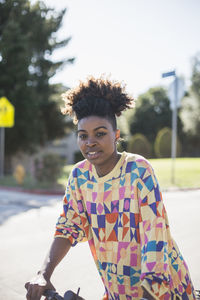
[55,175,86,246]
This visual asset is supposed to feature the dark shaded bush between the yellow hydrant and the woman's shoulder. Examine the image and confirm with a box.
[35,153,63,183]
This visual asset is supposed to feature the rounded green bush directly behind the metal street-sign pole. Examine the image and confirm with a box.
[154,127,181,158]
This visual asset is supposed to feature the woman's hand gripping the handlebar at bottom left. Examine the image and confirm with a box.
[25,273,55,300]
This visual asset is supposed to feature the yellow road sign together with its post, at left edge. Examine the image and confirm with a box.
[0,97,15,177]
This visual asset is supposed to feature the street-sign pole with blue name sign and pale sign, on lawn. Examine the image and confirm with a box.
[162,71,184,184]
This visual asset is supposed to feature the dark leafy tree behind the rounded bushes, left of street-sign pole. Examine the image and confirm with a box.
[130,87,182,152]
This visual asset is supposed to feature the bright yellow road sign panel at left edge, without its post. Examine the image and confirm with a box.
[0,97,15,127]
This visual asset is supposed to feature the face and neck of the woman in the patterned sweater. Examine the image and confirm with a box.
[78,116,120,176]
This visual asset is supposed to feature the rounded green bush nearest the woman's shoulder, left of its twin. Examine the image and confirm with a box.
[127,133,151,158]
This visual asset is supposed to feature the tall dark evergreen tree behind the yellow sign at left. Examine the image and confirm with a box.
[0,0,74,154]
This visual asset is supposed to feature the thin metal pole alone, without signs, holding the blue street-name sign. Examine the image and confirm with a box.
[171,76,178,184]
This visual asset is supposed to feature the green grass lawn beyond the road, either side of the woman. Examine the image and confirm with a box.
[0,158,200,190]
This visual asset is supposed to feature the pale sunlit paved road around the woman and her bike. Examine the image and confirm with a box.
[0,190,200,300]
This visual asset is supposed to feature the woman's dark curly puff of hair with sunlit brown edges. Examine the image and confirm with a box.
[62,76,134,120]
